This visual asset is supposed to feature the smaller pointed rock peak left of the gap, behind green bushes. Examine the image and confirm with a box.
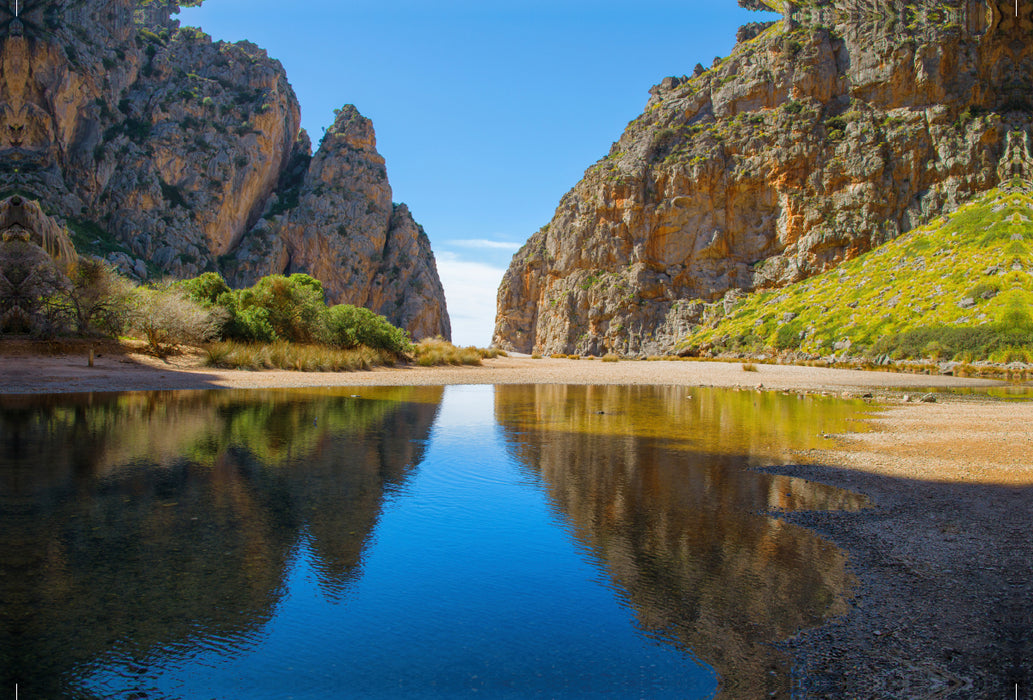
[224,105,450,338]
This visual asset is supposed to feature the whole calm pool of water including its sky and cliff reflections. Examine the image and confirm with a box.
[0,386,865,700]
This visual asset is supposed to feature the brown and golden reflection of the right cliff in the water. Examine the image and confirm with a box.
[496,386,864,698]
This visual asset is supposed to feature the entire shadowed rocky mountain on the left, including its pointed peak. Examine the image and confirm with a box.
[0,0,449,338]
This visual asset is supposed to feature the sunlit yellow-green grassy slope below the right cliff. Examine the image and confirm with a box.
[681,189,1033,361]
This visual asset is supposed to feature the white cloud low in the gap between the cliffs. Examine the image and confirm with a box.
[435,251,506,348]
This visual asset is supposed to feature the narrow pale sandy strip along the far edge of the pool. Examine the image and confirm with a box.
[0,354,1003,393]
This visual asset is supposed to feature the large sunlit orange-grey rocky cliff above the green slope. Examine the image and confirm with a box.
[494,0,1033,354]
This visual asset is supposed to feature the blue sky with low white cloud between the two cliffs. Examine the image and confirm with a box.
[180,0,764,346]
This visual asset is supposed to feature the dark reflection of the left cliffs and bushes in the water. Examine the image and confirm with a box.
[0,387,442,697]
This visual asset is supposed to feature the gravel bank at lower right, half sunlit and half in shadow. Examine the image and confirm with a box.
[778,402,1033,698]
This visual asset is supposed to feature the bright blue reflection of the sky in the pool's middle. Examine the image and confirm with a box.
[82,386,716,698]
